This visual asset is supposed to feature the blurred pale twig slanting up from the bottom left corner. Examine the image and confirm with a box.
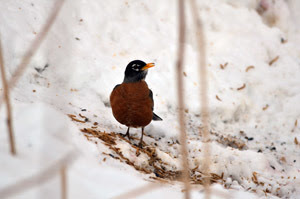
[0,151,77,199]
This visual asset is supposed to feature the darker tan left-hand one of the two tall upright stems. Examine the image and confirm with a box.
[176,0,190,199]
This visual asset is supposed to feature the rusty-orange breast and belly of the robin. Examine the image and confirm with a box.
[110,81,153,128]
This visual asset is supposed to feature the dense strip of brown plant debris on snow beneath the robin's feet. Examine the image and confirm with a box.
[80,128,224,184]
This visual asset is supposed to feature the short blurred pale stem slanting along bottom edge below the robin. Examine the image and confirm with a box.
[112,183,163,199]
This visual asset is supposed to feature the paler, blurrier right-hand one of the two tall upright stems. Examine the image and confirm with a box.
[190,0,211,199]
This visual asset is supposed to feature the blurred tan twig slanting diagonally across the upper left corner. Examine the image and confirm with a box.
[0,0,65,109]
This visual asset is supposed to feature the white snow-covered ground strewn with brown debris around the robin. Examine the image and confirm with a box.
[0,0,300,198]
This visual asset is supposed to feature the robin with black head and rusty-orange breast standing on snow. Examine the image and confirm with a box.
[110,60,162,148]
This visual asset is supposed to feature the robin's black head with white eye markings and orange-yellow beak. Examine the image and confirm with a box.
[123,60,154,83]
